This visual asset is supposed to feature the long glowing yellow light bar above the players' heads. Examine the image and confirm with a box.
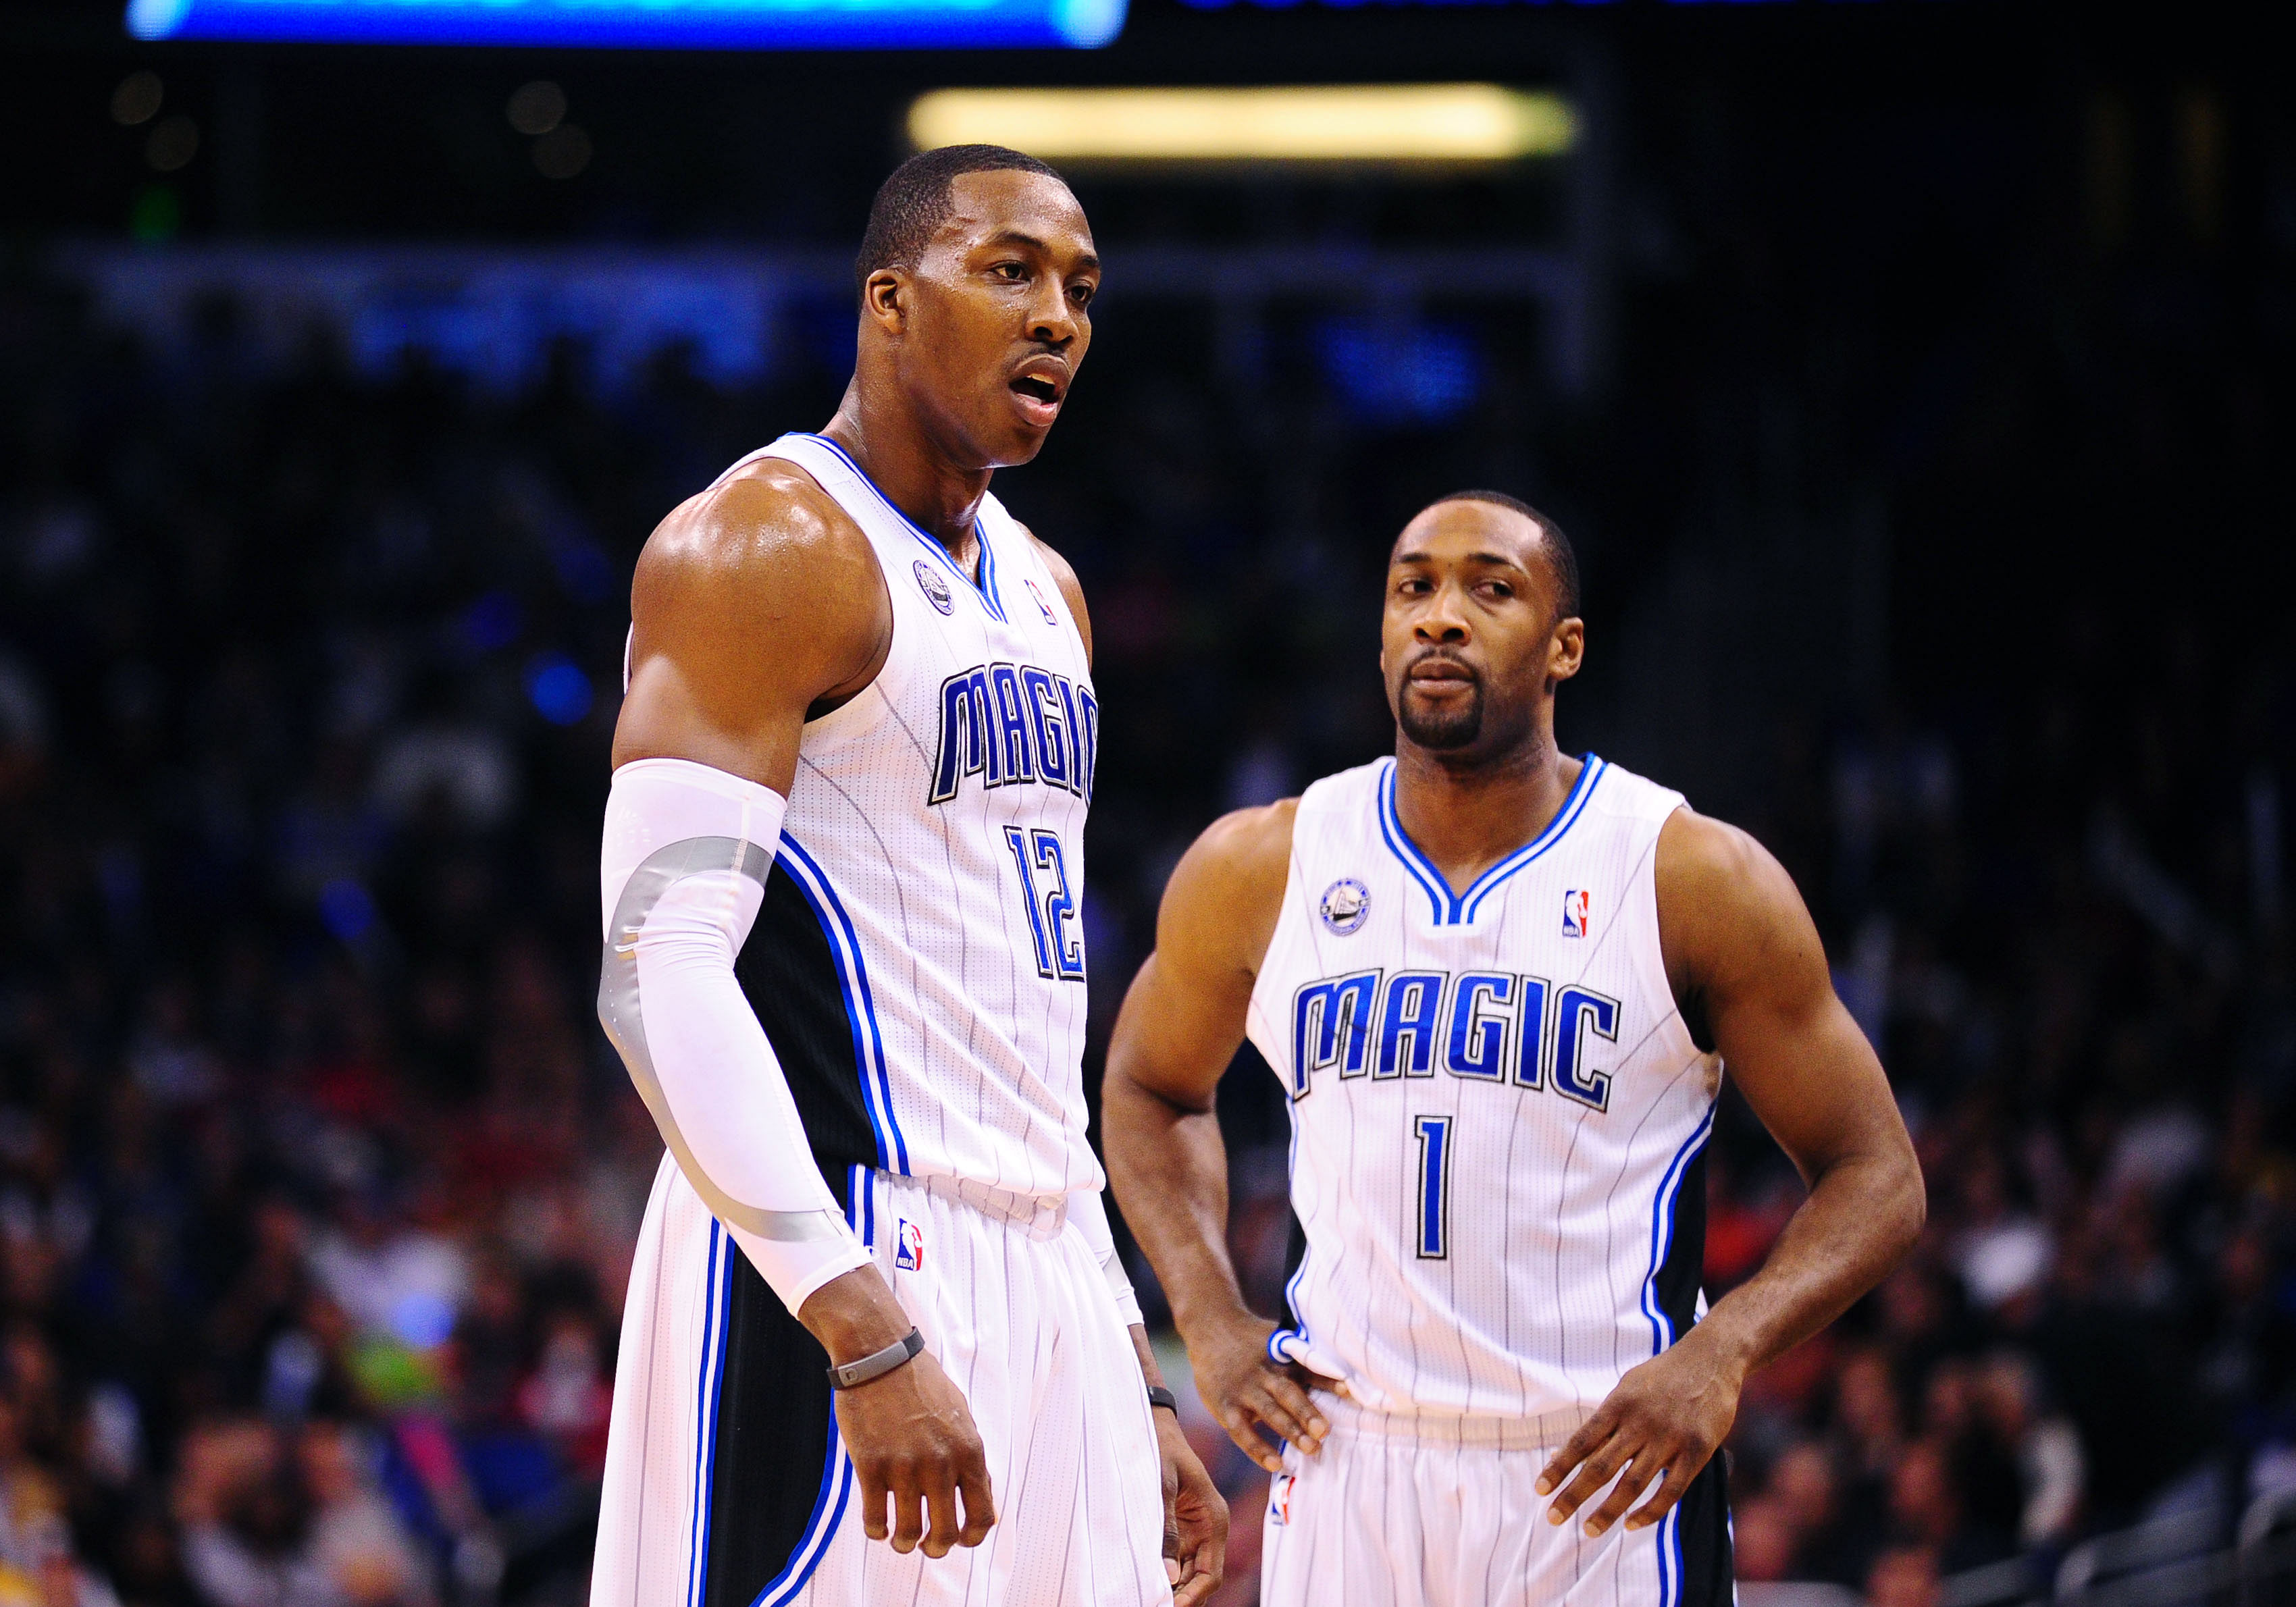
[909,82,1577,163]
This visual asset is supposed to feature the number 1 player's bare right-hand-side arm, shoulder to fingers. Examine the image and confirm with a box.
[1538,810,1927,1533]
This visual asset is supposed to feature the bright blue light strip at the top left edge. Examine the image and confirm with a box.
[126,0,1125,51]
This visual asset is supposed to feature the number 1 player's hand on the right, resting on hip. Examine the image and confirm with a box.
[1538,1329,1745,1536]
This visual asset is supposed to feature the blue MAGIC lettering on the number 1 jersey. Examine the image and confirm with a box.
[1288,971,1621,1111]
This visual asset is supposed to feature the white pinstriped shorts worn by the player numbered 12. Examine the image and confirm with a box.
[590,1157,1171,1607]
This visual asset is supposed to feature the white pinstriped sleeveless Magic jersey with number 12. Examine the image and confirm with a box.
[693,434,1104,1196]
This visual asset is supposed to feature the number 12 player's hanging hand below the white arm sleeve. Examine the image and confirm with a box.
[836,1350,997,1556]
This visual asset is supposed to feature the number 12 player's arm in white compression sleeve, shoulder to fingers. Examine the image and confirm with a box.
[599,464,994,1556]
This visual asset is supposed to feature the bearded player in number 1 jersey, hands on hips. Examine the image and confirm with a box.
[1104,492,1924,1607]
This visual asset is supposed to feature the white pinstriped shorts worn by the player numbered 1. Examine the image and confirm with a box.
[1261,1396,1736,1607]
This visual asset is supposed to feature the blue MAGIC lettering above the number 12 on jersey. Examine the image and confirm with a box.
[925,664,1100,804]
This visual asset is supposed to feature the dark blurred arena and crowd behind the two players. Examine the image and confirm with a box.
[0,0,2296,1607]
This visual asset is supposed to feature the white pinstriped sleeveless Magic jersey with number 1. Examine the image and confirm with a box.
[1249,756,1722,1419]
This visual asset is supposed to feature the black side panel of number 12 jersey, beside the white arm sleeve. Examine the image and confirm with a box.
[733,870,879,1184]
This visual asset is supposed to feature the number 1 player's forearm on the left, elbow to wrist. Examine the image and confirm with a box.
[1102,1065,1247,1336]
